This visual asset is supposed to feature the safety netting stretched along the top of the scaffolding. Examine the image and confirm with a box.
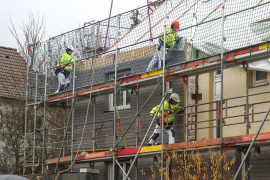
[26,0,270,98]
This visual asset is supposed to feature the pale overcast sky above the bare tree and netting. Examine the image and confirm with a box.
[0,0,147,48]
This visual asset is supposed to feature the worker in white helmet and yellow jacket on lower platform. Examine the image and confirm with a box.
[148,93,184,146]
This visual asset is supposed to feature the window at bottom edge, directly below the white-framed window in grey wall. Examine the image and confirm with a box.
[108,162,130,180]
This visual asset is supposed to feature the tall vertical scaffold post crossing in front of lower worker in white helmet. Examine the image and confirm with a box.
[160,0,168,180]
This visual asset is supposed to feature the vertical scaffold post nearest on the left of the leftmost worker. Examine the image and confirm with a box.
[42,50,48,174]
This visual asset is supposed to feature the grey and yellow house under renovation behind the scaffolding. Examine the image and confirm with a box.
[23,0,270,179]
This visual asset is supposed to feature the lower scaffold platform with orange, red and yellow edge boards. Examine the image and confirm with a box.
[46,132,270,165]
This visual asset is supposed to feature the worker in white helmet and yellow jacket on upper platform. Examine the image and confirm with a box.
[55,46,74,93]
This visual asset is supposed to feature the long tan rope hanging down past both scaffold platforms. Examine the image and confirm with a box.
[55,22,99,180]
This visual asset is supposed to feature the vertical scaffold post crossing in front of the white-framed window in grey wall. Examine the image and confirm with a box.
[112,15,120,179]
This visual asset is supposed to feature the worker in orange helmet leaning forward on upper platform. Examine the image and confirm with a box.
[146,21,181,71]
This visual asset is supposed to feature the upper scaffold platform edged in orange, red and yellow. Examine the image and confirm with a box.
[48,43,267,103]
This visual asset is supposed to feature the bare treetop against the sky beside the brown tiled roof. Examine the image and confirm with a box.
[9,12,45,68]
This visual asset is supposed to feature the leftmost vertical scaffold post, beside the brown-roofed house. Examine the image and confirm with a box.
[23,46,31,174]
